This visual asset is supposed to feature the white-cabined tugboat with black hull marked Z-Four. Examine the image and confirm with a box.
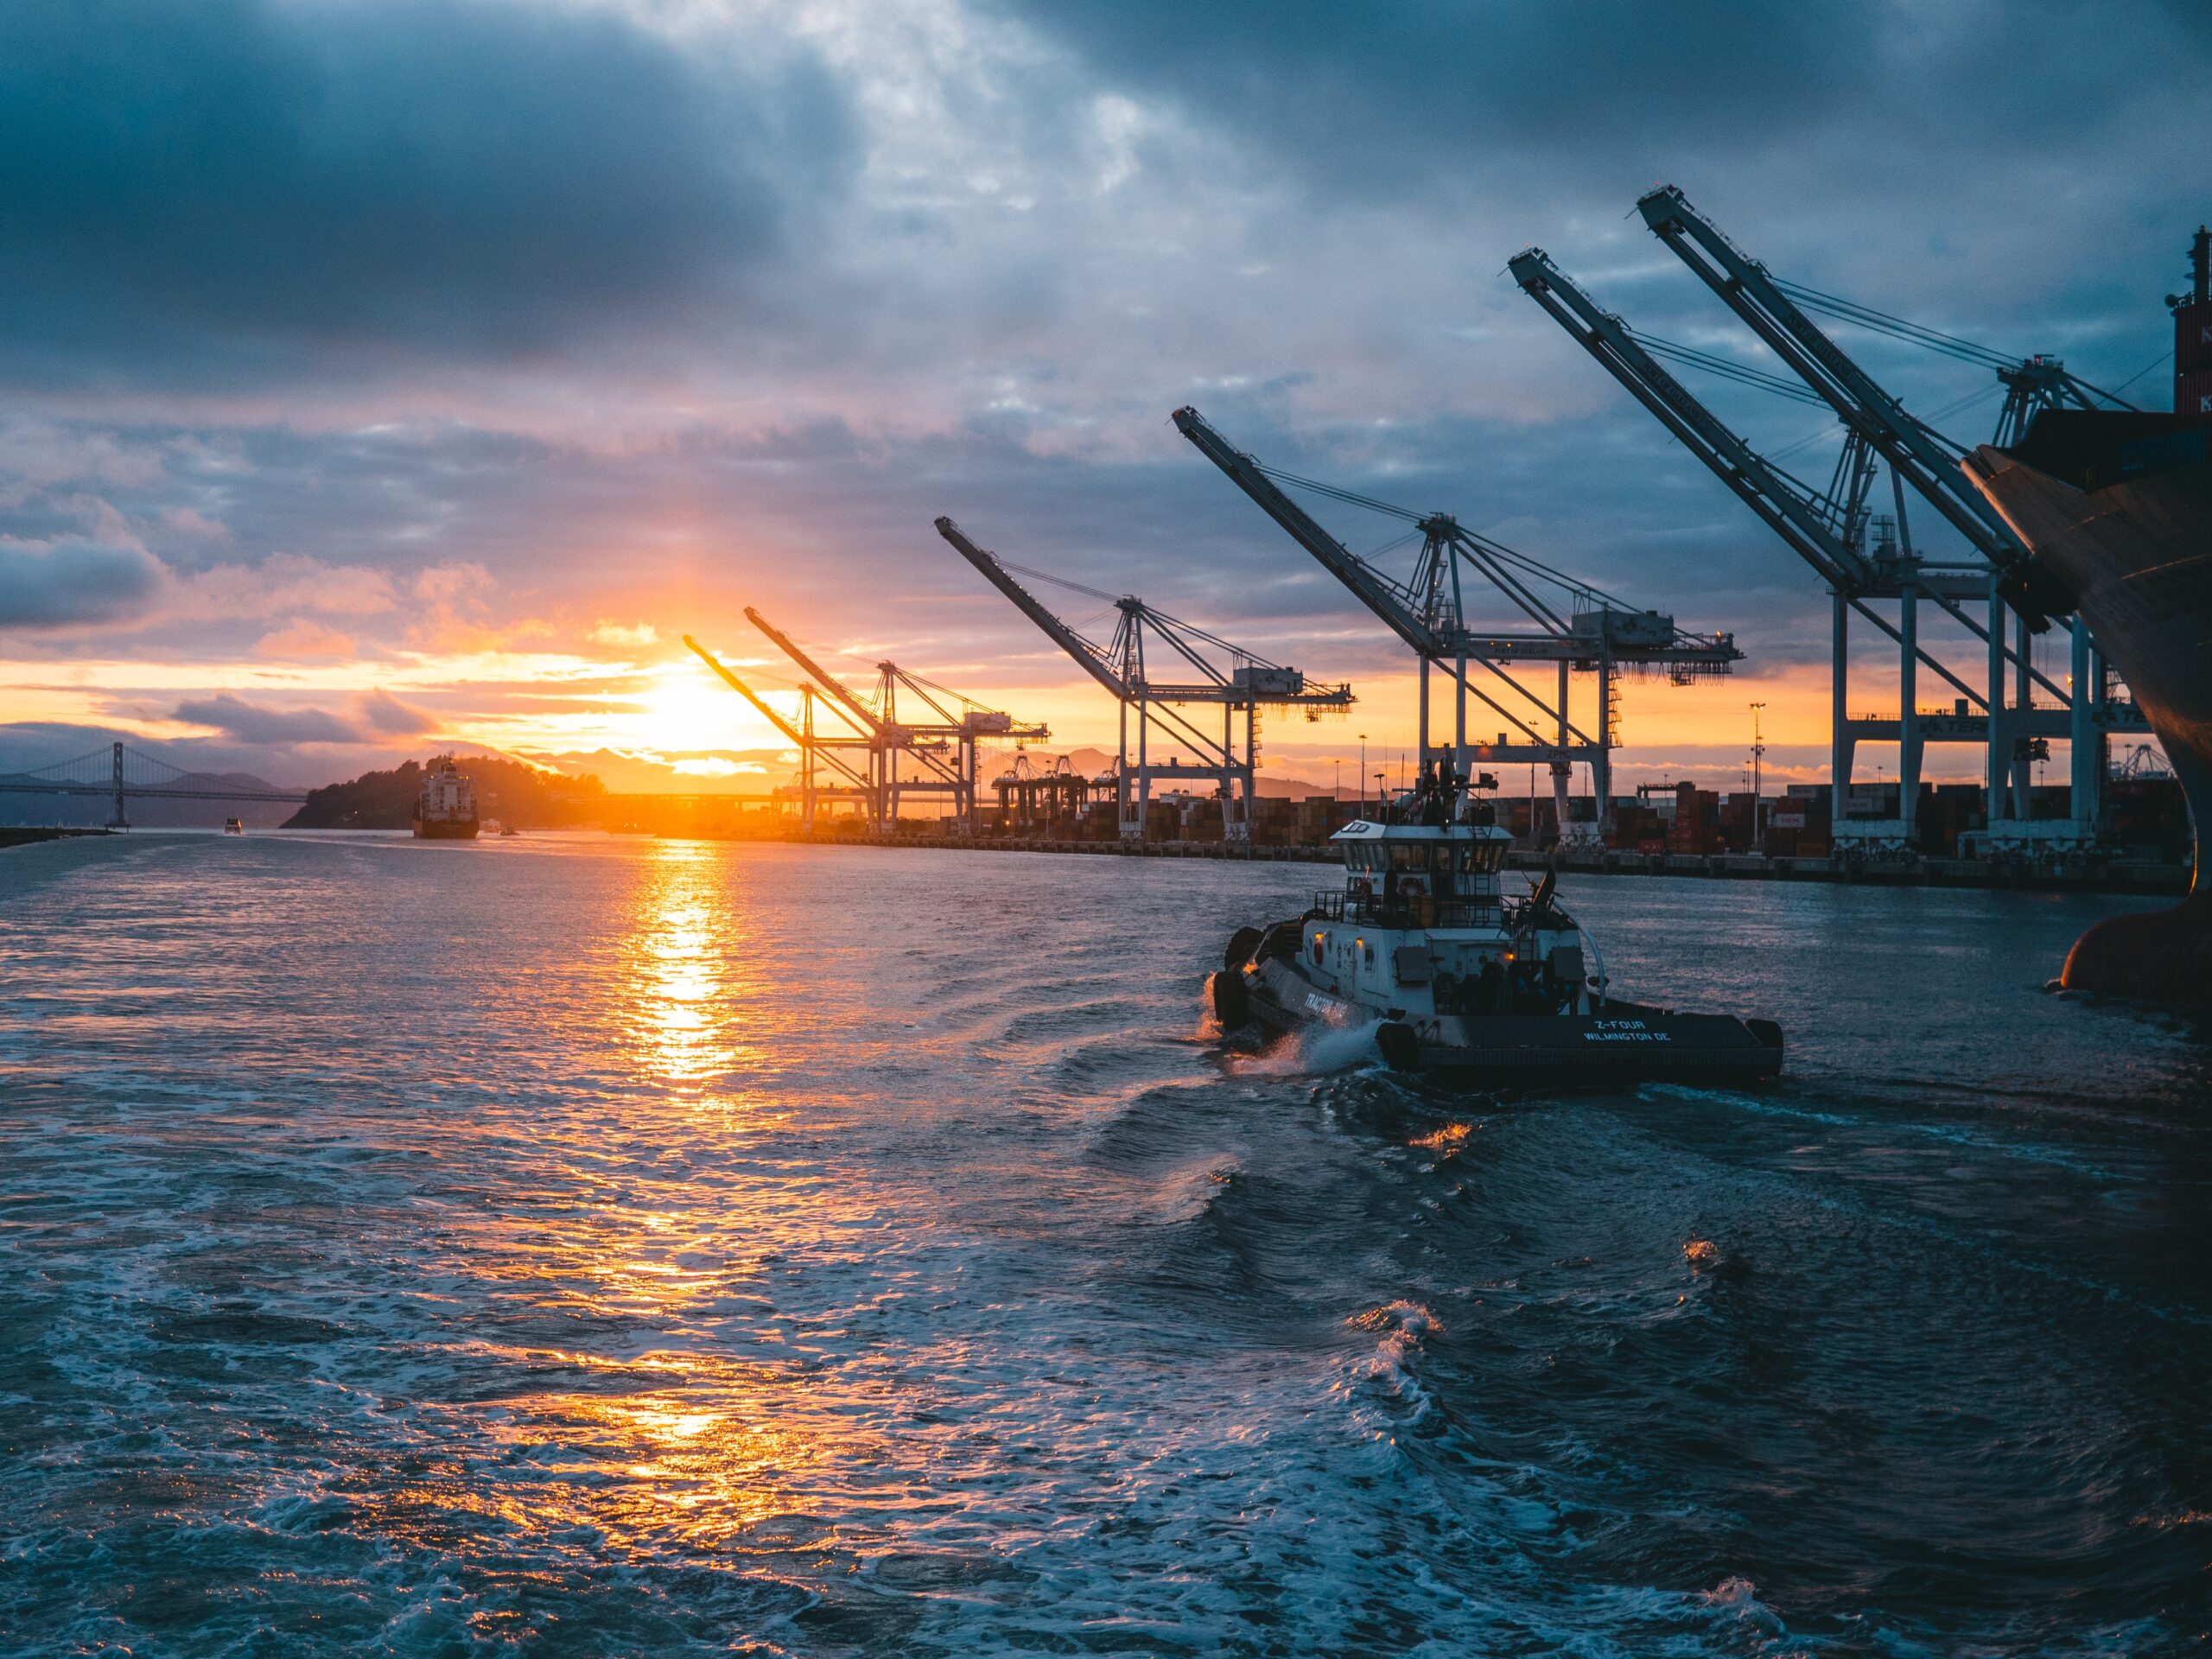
[1212,761,1783,1086]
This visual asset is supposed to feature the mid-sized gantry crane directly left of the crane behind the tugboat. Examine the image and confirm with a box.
[938,518,1354,841]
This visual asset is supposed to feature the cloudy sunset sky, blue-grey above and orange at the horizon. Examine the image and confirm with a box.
[0,0,2212,804]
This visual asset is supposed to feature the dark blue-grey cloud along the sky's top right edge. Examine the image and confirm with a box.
[998,0,2212,200]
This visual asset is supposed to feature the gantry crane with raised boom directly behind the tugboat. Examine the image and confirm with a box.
[1174,407,1743,838]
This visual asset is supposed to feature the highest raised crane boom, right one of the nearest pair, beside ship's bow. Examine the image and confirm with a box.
[1637,183,2073,631]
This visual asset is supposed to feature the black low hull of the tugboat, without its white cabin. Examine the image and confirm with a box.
[1214,960,1783,1086]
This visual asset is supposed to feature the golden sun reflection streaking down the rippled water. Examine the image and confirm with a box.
[346,841,896,1571]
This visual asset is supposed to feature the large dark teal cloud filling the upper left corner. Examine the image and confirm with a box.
[0,0,849,385]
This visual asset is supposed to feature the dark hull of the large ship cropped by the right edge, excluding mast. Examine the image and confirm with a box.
[1967,429,2212,1004]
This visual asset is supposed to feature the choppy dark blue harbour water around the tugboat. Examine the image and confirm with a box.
[0,836,2212,1656]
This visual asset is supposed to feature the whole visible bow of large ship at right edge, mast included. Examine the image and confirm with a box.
[1964,228,2212,1004]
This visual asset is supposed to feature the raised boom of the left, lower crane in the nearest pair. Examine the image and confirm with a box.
[1506,248,1873,595]
